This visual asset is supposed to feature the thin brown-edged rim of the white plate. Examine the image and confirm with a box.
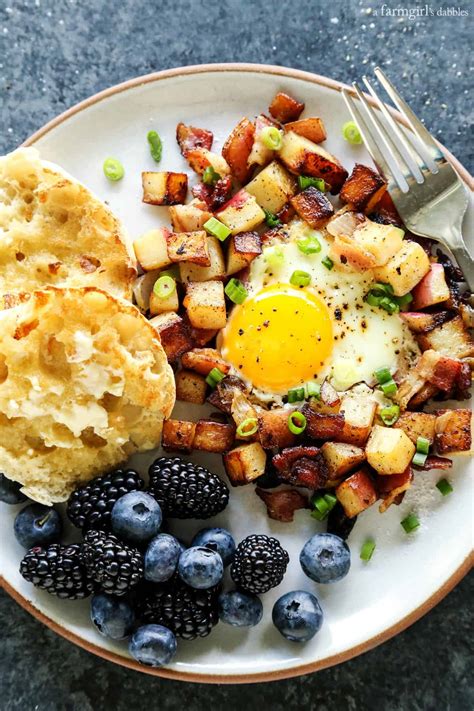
[0,62,474,684]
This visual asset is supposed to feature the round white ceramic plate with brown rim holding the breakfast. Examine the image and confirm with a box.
[0,65,472,682]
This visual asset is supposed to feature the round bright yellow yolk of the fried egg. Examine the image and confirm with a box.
[222,284,333,394]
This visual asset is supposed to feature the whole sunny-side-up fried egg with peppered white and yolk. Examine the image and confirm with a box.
[219,220,419,396]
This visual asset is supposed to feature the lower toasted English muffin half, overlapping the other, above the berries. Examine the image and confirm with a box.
[0,287,175,504]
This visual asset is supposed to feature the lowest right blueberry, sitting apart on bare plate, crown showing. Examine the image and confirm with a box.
[272,590,323,642]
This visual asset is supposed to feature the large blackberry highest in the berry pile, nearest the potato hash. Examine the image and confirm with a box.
[149,457,229,519]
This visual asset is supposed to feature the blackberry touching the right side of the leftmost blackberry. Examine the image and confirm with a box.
[83,531,143,595]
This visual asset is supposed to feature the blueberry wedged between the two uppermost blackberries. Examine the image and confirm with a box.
[110,491,162,543]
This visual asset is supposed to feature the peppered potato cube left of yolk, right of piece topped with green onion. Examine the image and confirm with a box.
[183,281,227,330]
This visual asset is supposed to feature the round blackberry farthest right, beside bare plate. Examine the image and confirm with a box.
[230,534,290,595]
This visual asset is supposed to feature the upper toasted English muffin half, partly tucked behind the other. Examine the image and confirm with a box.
[0,148,136,299]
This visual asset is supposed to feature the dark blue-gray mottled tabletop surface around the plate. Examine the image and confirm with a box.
[0,0,474,711]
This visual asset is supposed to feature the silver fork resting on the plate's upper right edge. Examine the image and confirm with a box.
[341,67,474,292]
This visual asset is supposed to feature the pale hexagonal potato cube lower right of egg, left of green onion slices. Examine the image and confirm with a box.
[365,425,416,474]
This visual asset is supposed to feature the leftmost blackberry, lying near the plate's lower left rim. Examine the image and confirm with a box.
[20,543,93,600]
